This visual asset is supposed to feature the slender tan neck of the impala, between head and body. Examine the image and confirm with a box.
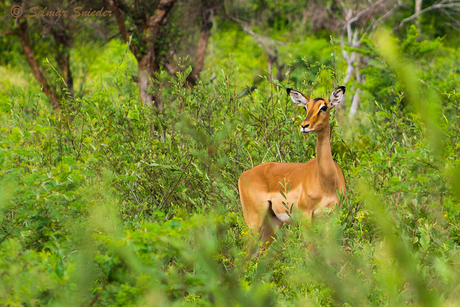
[316,125,337,192]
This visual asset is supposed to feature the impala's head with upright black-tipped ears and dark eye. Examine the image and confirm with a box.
[287,86,345,133]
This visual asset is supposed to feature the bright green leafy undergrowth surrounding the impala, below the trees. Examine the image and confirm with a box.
[0,28,460,306]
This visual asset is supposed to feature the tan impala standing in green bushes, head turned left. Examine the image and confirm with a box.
[238,86,345,248]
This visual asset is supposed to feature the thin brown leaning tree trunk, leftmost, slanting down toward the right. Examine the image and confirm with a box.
[19,19,62,110]
